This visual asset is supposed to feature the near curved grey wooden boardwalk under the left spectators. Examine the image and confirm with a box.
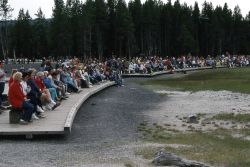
[0,81,114,138]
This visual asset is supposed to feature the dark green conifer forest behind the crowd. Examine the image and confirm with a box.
[0,0,250,59]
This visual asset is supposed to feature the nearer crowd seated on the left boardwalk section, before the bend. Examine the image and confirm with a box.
[0,58,123,124]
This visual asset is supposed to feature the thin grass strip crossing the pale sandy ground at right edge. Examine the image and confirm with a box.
[212,113,250,122]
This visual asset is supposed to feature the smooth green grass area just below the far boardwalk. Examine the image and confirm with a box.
[140,68,250,93]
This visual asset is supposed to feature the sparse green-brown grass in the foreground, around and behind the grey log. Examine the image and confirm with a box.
[138,122,250,167]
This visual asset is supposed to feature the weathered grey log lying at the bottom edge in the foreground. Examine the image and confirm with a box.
[152,151,209,167]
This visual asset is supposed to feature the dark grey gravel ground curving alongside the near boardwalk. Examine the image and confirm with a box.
[0,79,168,167]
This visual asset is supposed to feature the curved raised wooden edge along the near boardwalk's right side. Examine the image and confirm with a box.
[64,82,115,134]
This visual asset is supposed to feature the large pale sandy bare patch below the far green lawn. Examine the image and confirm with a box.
[149,90,250,134]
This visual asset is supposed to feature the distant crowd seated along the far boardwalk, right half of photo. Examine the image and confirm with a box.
[126,54,250,74]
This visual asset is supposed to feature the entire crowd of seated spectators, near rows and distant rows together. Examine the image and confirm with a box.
[0,54,249,124]
